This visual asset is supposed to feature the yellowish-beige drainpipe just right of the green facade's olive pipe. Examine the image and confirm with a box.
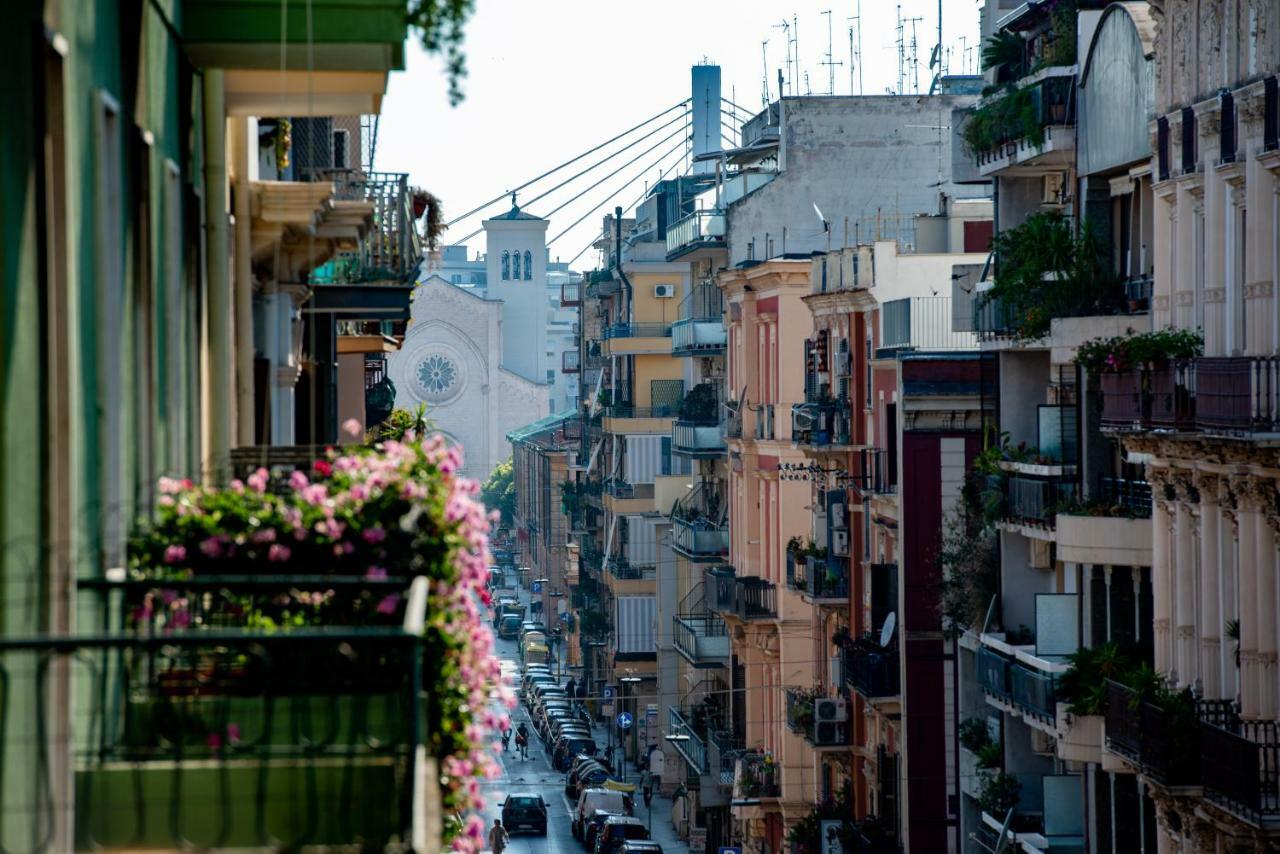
[230,118,257,446]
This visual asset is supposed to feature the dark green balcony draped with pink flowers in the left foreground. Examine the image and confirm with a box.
[49,438,502,850]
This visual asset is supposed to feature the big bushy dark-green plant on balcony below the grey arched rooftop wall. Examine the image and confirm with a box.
[984,211,1121,339]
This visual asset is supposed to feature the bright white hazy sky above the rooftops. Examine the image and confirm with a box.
[375,0,982,269]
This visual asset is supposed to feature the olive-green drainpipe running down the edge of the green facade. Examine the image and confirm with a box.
[202,68,236,484]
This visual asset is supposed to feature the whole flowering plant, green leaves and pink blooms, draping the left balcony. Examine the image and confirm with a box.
[128,426,515,848]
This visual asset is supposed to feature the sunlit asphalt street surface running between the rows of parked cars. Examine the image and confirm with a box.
[484,590,689,854]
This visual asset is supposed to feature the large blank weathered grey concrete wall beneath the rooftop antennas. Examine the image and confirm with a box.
[728,96,986,265]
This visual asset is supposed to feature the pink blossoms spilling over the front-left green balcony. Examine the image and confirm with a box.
[143,435,499,851]
